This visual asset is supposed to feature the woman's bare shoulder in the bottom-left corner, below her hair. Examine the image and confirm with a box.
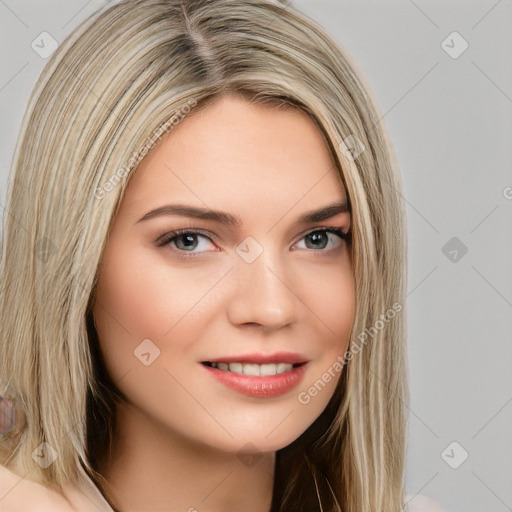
[0,465,76,512]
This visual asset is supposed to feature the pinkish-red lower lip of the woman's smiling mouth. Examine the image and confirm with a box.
[201,363,307,398]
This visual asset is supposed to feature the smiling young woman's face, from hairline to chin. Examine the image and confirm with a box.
[94,96,355,452]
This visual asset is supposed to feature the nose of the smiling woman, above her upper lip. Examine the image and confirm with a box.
[228,251,300,330]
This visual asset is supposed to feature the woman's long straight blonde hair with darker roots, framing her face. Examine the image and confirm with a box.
[0,0,409,512]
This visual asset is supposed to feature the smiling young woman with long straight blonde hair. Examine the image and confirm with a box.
[0,0,442,512]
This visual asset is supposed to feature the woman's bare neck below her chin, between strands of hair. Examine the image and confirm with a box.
[99,404,275,512]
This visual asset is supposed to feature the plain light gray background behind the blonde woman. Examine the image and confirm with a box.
[0,0,512,512]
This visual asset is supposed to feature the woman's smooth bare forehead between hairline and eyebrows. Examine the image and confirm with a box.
[121,96,346,218]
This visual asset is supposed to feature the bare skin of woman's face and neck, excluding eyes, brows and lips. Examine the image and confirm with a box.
[93,95,355,512]
